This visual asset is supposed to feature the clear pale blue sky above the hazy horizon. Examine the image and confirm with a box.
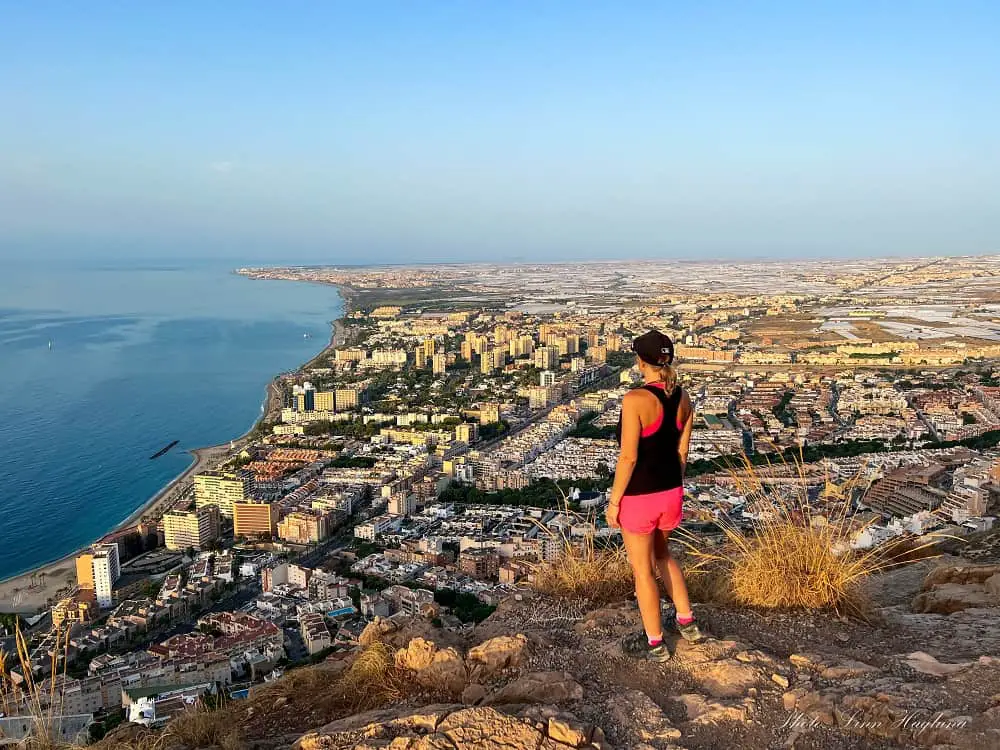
[0,0,1000,263]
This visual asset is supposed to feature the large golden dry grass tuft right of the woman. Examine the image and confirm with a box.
[677,450,939,619]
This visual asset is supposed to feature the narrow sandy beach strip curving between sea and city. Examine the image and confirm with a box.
[0,284,353,615]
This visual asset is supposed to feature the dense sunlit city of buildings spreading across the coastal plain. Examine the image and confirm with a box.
[1,257,1000,740]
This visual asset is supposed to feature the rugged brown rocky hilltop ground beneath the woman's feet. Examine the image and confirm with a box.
[99,538,1000,750]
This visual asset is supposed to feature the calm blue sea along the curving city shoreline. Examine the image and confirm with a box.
[0,263,343,579]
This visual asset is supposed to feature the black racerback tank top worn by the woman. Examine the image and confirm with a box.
[618,385,684,495]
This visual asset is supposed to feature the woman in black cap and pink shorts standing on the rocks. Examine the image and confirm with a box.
[607,331,701,661]
